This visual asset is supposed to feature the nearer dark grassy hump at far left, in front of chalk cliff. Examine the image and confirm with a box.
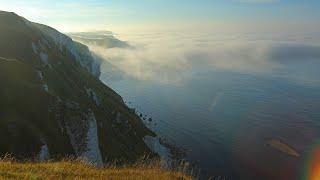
[0,58,72,157]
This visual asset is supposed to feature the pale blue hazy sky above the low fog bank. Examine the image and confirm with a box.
[0,0,320,31]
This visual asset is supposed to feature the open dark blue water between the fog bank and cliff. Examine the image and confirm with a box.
[101,52,320,179]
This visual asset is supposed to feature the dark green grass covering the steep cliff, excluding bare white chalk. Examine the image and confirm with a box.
[0,11,154,163]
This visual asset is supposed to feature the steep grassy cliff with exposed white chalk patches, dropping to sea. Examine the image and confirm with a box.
[0,11,154,164]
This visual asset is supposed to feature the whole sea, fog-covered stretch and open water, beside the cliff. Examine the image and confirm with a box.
[72,31,320,179]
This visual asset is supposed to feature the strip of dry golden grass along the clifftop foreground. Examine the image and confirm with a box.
[0,161,192,180]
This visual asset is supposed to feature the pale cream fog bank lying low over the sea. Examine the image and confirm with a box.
[77,32,320,84]
